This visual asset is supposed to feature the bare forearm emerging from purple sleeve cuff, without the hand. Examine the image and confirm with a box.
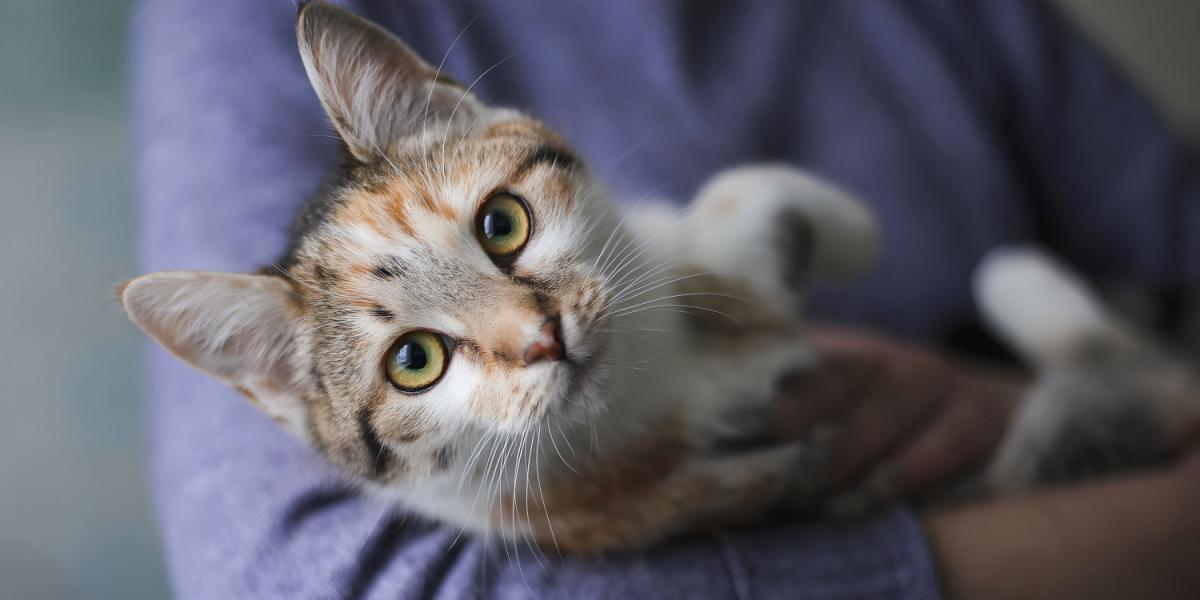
[923,467,1200,600]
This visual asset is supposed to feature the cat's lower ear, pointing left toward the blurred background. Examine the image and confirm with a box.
[118,271,308,437]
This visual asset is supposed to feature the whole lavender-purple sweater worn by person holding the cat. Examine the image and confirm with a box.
[134,0,1200,599]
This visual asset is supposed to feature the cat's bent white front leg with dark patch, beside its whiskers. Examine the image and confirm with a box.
[682,166,880,329]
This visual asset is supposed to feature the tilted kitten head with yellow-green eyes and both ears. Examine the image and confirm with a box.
[120,2,617,479]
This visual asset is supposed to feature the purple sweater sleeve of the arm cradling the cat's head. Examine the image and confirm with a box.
[132,0,936,599]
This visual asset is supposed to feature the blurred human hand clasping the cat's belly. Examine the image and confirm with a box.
[775,329,1026,498]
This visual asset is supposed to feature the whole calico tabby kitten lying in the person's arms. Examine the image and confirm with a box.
[119,1,1195,554]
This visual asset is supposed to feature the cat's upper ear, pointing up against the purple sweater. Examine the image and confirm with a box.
[296,1,486,162]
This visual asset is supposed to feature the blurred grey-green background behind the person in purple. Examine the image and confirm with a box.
[0,0,1200,600]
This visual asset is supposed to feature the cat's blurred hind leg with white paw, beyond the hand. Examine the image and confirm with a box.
[977,250,1200,491]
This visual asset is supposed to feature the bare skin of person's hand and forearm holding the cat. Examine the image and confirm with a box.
[778,329,1200,599]
